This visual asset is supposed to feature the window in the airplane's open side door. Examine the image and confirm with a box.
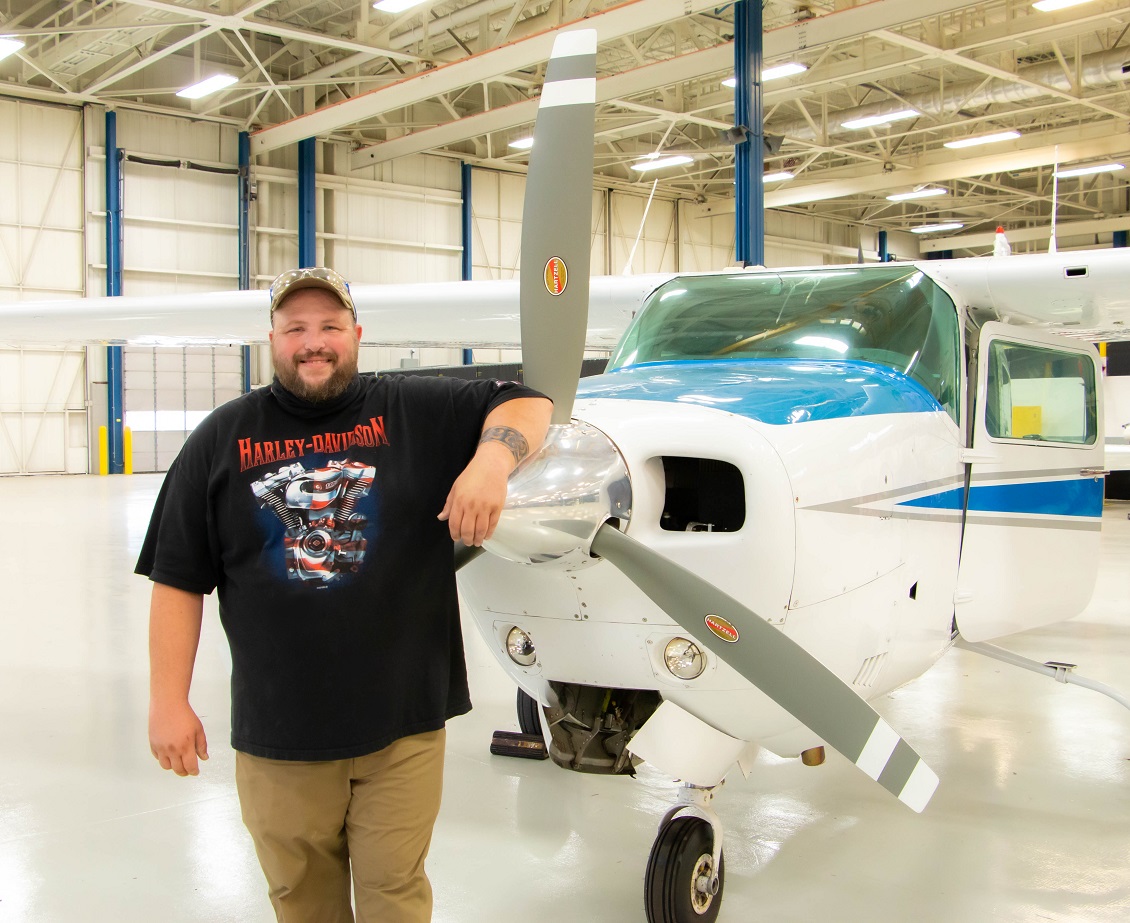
[985,340,1098,445]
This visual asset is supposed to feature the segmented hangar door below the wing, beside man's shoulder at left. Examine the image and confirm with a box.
[122,346,243,472]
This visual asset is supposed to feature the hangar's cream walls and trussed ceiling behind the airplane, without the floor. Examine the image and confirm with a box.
[0,0,1130,473]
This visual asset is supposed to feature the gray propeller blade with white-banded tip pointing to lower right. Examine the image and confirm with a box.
[592,523,938,811]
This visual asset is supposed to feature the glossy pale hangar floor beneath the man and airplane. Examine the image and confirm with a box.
[0,476,1130,923]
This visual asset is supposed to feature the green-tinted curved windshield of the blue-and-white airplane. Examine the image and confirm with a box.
[609,263,959,420]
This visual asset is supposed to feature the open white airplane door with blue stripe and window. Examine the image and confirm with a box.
[954,323,1104,641]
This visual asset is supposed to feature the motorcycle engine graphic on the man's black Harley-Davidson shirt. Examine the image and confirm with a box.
[251,461,376,583]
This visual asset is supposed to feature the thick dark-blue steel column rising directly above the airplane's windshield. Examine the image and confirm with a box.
[733,0,765,265]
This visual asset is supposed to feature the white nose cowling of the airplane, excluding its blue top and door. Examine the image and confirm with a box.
[461,381,963,755]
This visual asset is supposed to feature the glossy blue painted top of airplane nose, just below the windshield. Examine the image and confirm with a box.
[577,359,945,425]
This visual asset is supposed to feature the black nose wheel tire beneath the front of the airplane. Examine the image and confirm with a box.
[643,815,725,923]
